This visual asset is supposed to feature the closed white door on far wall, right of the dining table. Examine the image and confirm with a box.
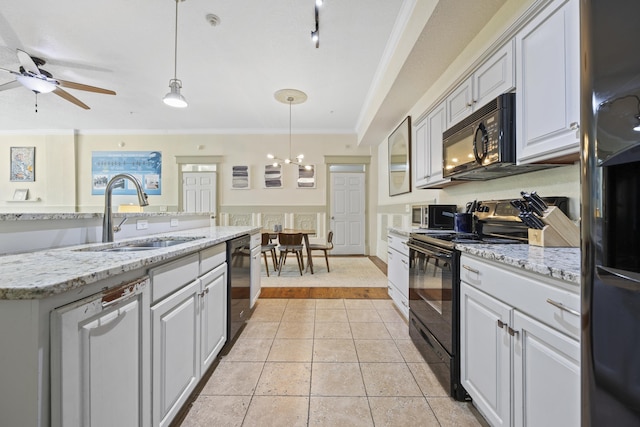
[331,172,365,255]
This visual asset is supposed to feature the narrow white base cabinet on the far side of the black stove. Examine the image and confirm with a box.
[387,233,409,320]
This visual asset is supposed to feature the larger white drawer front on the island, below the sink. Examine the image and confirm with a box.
[149,254,200,304]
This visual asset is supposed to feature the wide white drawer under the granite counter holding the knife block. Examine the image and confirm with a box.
[460,255,580,339]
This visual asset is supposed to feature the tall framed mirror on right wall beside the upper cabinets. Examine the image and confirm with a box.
[389,116,411,196]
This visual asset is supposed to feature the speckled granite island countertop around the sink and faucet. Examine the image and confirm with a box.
[0,226,260,299]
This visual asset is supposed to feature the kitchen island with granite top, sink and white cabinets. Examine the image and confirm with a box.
[0,227,260,426]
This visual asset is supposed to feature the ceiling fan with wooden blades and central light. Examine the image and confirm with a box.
[0,49,116,111]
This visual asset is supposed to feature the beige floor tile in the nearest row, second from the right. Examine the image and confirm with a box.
[369,397,440,427]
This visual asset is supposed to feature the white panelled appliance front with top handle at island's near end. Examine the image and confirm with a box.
[51,278,151,427]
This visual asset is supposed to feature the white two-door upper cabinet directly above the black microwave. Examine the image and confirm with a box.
[445,41,515,129]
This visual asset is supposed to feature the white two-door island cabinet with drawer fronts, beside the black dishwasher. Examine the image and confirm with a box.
[149,244,228,426]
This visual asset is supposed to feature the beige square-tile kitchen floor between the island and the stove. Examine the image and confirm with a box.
[182,299,487,427]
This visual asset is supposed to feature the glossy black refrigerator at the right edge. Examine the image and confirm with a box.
[580,0,640,427]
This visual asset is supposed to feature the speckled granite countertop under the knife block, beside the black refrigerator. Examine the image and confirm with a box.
[456,244,581,285]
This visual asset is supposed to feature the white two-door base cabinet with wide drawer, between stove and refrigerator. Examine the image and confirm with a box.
[460,254,580,427]
